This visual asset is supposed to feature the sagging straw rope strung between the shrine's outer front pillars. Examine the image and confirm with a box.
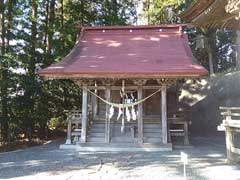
[83,87,162,108]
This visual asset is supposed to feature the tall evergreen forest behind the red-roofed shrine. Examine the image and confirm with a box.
[0,0,239,144]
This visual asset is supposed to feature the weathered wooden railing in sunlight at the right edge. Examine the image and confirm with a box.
[218,107,240,162]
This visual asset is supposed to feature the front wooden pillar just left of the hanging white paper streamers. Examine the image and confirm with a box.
[105,84,111,143]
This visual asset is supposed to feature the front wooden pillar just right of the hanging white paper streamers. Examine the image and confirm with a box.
[137,84,143,144]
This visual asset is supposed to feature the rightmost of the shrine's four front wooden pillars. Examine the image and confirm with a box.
[161,84,168,144]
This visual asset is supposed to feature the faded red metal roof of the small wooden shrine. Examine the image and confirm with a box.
[39,25,208,78]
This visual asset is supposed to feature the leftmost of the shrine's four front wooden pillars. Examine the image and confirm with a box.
[81,84,88,143]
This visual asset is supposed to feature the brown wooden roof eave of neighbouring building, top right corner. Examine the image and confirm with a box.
[180,0,240,29]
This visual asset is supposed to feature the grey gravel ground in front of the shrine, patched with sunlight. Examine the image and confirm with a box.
[0,137,240,180]
